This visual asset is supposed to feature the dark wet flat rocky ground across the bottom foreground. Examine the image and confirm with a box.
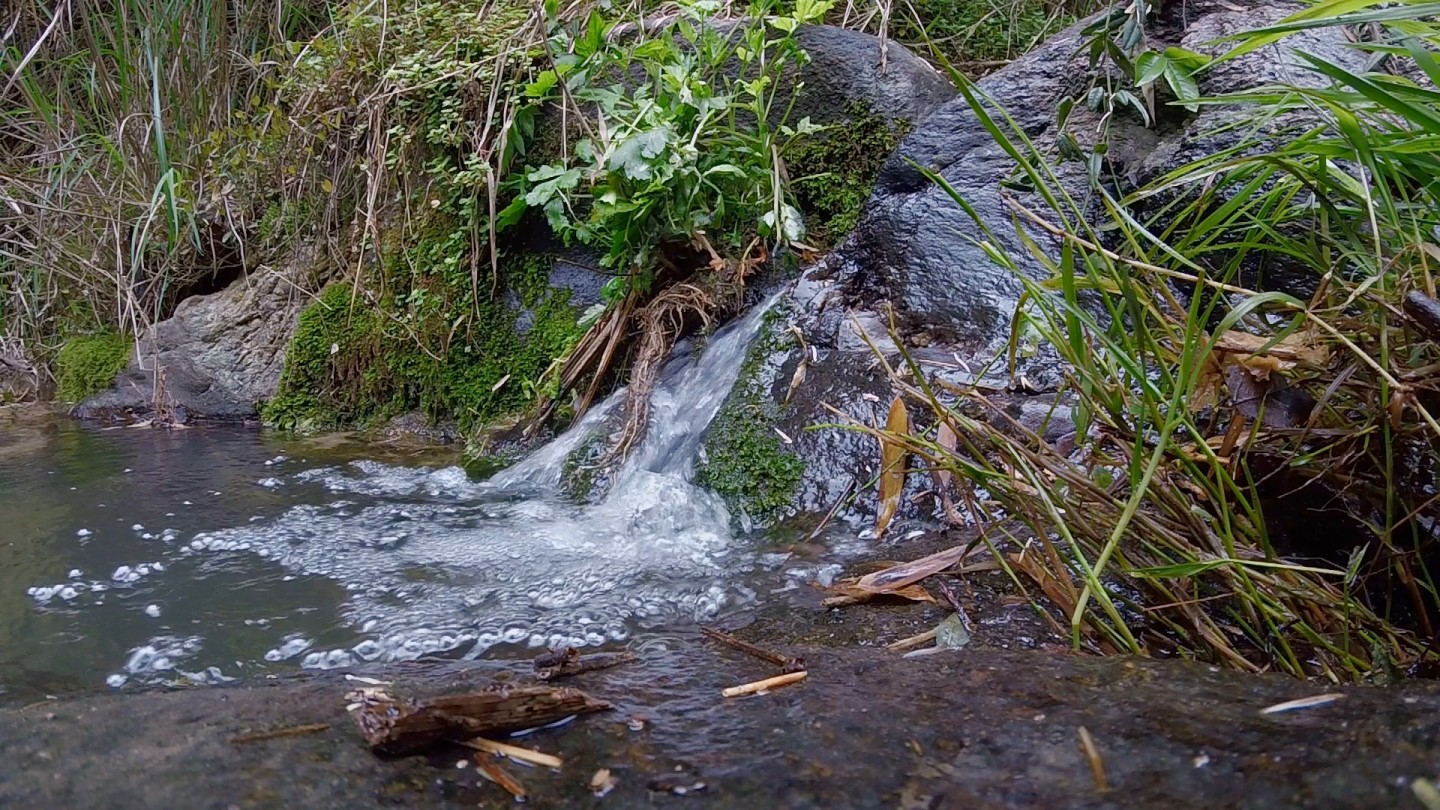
[0,608,1440,809]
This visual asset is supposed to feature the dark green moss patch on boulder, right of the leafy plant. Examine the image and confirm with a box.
[786,102,910,246]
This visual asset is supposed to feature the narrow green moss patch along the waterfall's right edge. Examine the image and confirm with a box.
[696,305,805,523]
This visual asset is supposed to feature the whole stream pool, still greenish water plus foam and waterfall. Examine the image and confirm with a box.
[0,296,840,700]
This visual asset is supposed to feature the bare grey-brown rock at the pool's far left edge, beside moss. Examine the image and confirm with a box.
[78,248,318,419]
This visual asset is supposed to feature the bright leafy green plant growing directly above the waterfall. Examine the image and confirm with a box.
[505,0,832,300]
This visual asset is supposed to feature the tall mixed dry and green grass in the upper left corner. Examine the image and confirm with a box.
[0,0,325,355]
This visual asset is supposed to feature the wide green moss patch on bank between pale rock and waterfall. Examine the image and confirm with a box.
[262,236,580,430]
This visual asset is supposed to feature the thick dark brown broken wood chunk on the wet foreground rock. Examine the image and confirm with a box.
[356,685,612,754]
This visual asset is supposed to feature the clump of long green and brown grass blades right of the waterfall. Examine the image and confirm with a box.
[875,1,1440,682]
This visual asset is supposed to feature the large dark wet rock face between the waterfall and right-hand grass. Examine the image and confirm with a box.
[720,0,1365,523]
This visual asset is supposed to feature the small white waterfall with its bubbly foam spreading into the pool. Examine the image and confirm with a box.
[180,289,775,667]
